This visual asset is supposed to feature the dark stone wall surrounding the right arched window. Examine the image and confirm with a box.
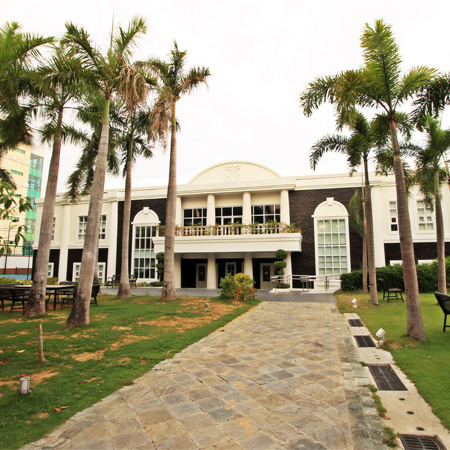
[289,188,362,275]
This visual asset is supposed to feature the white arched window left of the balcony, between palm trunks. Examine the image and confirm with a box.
[131,207,160,281]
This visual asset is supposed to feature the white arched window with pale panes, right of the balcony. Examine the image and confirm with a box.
[313,197,350,275]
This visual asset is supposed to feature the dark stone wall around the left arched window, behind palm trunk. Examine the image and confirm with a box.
[114,198,166,274]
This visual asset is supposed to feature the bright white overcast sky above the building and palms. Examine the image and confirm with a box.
[0,0,450,191]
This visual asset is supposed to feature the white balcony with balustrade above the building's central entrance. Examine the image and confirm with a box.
[154,222,302,253]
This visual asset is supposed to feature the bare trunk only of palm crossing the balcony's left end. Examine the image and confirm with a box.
[161,102,177,300]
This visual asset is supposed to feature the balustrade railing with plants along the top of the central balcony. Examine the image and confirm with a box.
[169,222,301,236]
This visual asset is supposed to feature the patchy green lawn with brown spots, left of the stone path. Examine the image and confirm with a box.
[0,296,259,449]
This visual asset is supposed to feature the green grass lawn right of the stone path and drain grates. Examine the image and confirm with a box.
[336,292,450,429]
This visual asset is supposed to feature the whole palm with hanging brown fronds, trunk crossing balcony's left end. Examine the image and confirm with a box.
[146,42,210,300]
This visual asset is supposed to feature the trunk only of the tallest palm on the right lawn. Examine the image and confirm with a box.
[389,119,426,341]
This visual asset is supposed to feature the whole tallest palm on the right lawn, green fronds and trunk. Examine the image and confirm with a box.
[300,20,437,341]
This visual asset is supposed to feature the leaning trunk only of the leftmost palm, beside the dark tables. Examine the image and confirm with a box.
[22,108,63,317]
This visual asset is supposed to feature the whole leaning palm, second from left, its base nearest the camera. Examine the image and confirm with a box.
[63,18,147,327]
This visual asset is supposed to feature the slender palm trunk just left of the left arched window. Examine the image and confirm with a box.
[117,148,133,298]
